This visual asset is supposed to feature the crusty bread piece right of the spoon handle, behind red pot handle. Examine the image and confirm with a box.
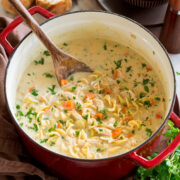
[36,0,72,15]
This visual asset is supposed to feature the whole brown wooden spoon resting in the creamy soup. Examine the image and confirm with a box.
[9,0,93,85]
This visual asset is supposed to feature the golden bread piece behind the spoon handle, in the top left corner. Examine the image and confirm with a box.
[1,0,34,14]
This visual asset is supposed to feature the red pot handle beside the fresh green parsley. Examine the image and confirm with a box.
[129,112,180,169]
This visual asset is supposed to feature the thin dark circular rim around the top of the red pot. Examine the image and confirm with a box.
[4,10,176,162]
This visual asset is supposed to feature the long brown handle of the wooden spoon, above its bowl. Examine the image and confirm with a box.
[9,0,63,55]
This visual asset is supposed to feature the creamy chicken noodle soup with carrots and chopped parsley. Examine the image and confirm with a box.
[16,38,166,159]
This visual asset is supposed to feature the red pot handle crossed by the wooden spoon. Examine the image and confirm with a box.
[0,6,55,55]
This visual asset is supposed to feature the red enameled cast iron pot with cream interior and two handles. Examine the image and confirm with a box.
[0,7,180,180]
